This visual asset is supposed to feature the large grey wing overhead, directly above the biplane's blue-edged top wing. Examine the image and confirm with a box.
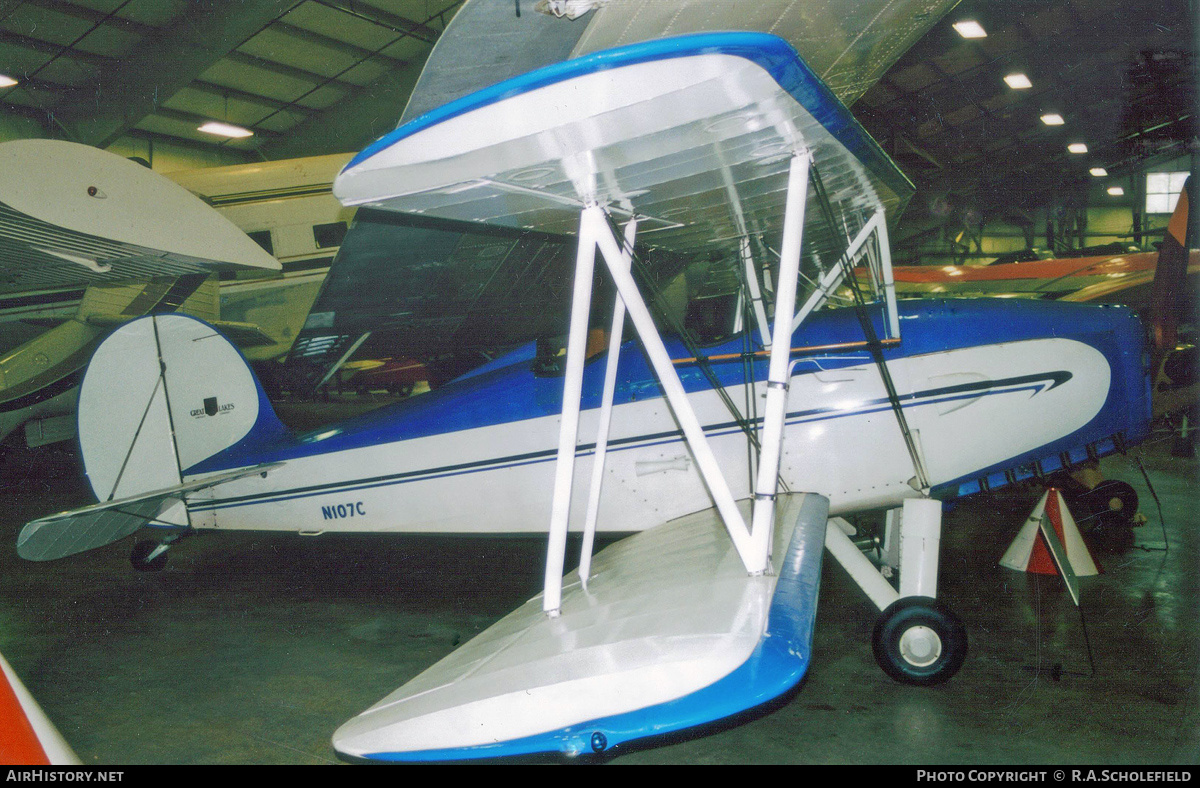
[401,0,956,122]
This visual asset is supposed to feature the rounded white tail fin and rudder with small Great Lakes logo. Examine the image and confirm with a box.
[78,314,287,503]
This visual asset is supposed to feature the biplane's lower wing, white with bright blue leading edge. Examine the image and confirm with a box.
[334,494,829,760]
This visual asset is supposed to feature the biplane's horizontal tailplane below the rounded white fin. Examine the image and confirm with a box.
[17,463,282,561]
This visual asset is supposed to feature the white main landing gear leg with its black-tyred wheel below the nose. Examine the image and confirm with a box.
[826,499,967,686]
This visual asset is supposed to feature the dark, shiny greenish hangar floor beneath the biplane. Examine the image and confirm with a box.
[0,400,1200,765]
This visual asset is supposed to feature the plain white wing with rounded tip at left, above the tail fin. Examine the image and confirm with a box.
[0,139,280,298]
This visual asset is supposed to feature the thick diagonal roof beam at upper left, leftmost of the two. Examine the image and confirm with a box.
[54,0,304,148]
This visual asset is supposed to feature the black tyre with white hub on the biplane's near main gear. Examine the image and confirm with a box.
[871,596,967,686]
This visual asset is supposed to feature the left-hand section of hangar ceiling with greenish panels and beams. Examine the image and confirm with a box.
[0,0,461,158]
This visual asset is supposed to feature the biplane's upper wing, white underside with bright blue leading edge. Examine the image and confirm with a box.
[334,34,912,254]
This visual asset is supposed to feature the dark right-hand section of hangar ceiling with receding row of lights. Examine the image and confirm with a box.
[853,0,1196,218]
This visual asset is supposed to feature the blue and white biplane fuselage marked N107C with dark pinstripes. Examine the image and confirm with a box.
[174,300,1150,533]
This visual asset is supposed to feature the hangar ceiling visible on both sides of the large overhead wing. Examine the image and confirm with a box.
[0,0,1196,235]
